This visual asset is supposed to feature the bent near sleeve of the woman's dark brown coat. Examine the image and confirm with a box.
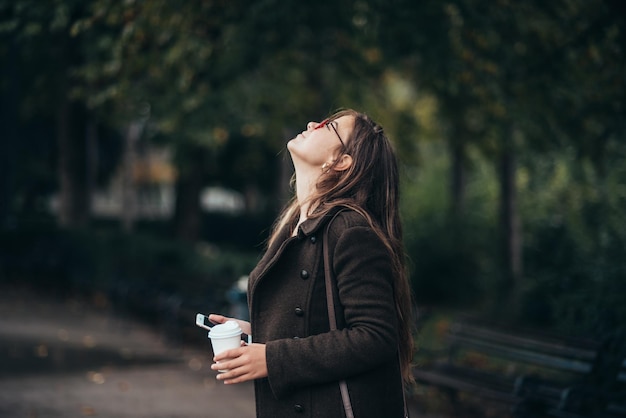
[266,226,398,398]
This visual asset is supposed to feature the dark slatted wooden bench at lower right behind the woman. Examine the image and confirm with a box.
[414,317,616,418]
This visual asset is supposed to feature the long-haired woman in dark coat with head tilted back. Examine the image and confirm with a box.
[209,110,413,418]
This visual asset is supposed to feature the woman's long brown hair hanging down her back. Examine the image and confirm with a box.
[269,109,413,382]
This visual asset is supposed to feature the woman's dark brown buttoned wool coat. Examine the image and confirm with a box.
[248,210,403,418]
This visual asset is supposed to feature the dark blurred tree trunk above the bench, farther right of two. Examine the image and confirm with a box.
[499,125,522,316]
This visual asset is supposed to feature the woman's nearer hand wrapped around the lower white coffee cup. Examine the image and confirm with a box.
[211,344,267,385]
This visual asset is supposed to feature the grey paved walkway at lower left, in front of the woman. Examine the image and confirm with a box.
[0,287,255,418]
